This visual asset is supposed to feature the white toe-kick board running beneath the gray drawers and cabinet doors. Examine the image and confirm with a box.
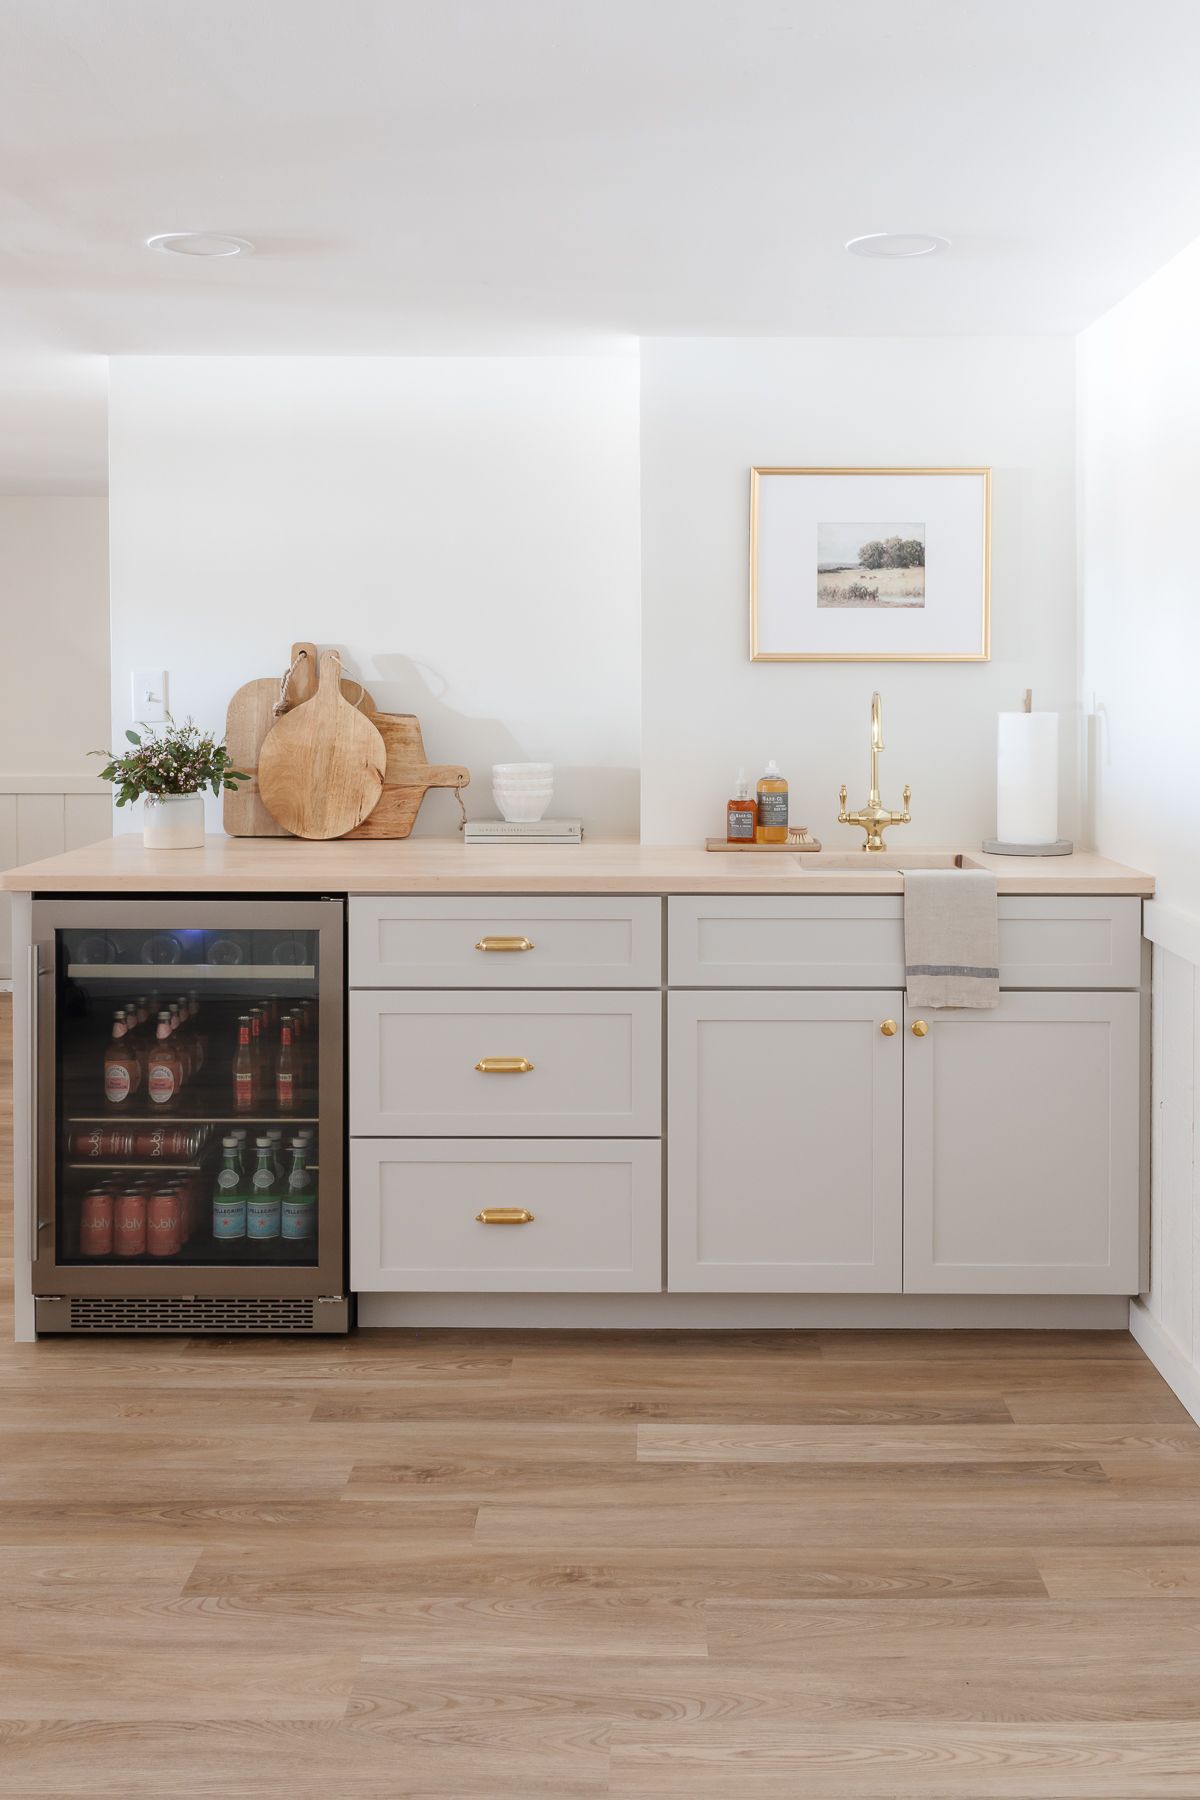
[358,1294,1130,1332]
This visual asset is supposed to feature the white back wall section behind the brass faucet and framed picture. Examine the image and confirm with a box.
[642,337,1078,848]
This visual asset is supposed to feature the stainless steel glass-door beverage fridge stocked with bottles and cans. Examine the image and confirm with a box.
[31,898,349,1332]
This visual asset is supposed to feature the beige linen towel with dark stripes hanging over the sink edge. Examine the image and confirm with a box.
[905,869,1000,1008]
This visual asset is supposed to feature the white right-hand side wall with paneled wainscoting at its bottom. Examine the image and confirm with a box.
[1078,243,1200,1411]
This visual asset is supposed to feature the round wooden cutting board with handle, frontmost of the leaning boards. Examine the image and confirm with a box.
[259,652,387,839]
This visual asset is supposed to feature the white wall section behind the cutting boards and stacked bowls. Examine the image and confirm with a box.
[110,355,639,835]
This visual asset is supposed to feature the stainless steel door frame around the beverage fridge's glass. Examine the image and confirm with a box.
[31,895,345,1300]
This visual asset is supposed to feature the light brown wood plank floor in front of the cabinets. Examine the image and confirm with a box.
[0,1008,1200,1800]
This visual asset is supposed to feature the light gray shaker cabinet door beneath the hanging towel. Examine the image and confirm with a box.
[905,992,1141,1294]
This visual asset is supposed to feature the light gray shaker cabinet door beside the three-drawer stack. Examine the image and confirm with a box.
[667,990,903,1294]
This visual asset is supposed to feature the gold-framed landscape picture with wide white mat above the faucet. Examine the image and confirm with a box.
[750,468,991,662]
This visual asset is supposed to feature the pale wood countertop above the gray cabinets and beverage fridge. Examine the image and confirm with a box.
[0,833,1155,895]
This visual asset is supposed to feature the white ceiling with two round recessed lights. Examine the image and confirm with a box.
[0,0,1200,491]
